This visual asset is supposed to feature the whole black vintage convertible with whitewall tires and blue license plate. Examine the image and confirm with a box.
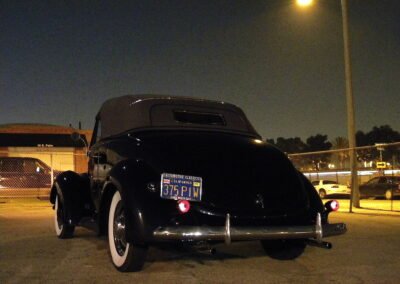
[50,95,346,271]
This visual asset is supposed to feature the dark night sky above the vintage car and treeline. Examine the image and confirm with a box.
[0,0,400,139]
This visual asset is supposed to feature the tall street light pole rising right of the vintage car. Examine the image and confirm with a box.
[341,0,360,209]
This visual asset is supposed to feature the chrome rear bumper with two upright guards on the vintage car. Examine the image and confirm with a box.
[153,213,347,244]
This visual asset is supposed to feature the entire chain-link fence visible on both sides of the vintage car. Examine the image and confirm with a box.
[0,142,400,210]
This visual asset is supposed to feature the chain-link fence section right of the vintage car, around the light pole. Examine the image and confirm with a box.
[288,142,400,210]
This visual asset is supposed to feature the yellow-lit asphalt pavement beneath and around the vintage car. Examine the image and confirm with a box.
[0,199,400,284]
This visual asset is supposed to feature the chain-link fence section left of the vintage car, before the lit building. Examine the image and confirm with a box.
[0,149,86,199]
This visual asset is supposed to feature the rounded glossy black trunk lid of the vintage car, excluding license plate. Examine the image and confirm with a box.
[137,131,309,217]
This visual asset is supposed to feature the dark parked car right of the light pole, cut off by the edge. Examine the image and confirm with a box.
[360,176,400,199]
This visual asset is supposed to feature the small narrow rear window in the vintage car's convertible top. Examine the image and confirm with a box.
[173,110,226,126]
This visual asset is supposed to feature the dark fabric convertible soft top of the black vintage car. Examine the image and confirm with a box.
[96,95,260,138]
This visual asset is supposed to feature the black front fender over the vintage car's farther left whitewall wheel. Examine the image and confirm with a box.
[50,171,90,225]
